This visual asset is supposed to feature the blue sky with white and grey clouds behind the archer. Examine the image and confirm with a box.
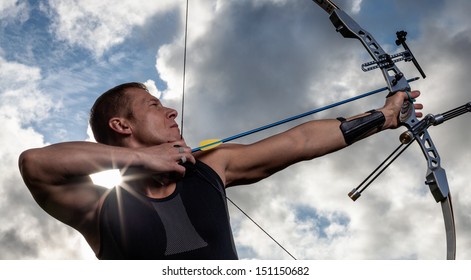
[0,0,471,260]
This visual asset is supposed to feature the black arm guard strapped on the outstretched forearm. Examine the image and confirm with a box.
[337,110,386,145]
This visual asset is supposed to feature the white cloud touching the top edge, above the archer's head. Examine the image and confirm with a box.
[46,0,176,57]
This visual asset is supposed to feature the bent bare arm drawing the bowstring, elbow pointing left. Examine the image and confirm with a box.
[19,141,191,250]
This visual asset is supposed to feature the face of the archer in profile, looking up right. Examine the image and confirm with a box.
[127,88,181,146]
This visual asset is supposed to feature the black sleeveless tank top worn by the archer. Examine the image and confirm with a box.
[97,161,237,260]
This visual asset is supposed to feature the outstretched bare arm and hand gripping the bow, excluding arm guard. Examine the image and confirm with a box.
[198,91,422,186]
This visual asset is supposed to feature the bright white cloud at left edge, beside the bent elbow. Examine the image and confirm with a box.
[0,55,91,259]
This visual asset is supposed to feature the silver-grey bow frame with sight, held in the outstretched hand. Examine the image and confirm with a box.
[313,0,456,259]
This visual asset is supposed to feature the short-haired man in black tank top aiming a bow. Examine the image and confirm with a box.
[19,83,422,259]
